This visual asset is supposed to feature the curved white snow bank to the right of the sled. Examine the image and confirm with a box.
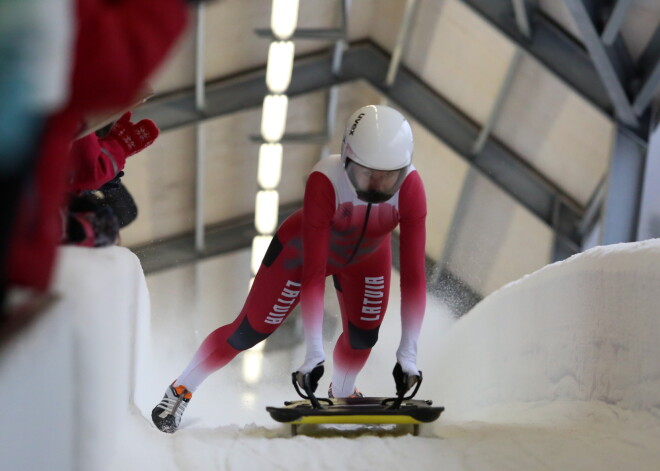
[428,240,660,420]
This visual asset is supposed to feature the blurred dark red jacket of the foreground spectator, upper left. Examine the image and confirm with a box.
[9,0,187,290]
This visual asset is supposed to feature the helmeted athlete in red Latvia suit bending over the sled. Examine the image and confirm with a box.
[152,105,426,433]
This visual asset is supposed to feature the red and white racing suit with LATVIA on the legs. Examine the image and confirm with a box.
[176,155,426,397]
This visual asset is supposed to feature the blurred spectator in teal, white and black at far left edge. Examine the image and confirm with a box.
[0,0,74,314]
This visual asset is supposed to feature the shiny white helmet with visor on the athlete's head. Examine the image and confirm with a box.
[341,105,413,203]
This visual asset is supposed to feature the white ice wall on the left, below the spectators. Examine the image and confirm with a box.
[0,247,149,471]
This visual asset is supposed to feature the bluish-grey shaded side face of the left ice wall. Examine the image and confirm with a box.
[0,282,75,471]
